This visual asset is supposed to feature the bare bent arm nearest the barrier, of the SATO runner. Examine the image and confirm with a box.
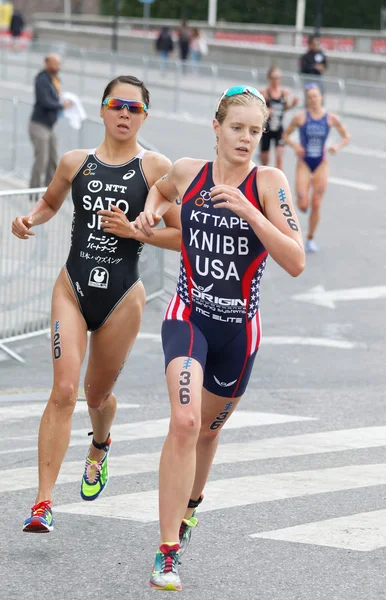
[12,150,87,240]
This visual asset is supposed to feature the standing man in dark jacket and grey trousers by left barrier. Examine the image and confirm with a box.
[29,54,71,188]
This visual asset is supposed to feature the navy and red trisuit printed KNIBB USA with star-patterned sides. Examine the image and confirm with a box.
[162,162,268,398]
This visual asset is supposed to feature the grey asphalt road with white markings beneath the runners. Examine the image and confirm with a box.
[0,56,386,600]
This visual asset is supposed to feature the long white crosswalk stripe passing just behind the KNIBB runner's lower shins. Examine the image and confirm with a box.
[55,463,386,524]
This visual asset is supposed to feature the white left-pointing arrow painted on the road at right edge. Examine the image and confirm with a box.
[292,285,386,308]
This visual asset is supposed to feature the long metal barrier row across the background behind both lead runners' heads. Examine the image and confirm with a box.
[0,41,386,118]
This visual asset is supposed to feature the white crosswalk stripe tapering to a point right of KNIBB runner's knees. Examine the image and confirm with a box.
[0,410,315,455]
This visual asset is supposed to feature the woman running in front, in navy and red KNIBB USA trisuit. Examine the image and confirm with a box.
[135,86,304,590]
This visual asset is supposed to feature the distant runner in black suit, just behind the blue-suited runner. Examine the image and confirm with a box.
[260,66,299,171]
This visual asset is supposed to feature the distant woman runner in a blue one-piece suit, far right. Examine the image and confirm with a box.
[283,83,350,252]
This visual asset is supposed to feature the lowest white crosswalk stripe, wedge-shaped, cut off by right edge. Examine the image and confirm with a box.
[250,510,386,552]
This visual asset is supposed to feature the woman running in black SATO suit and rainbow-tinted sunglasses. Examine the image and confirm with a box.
[12,76,181,533]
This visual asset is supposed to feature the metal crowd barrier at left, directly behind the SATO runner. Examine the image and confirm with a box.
[0,188,164,362]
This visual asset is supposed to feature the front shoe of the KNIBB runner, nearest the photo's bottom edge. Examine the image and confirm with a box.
[149,544,182,592]
